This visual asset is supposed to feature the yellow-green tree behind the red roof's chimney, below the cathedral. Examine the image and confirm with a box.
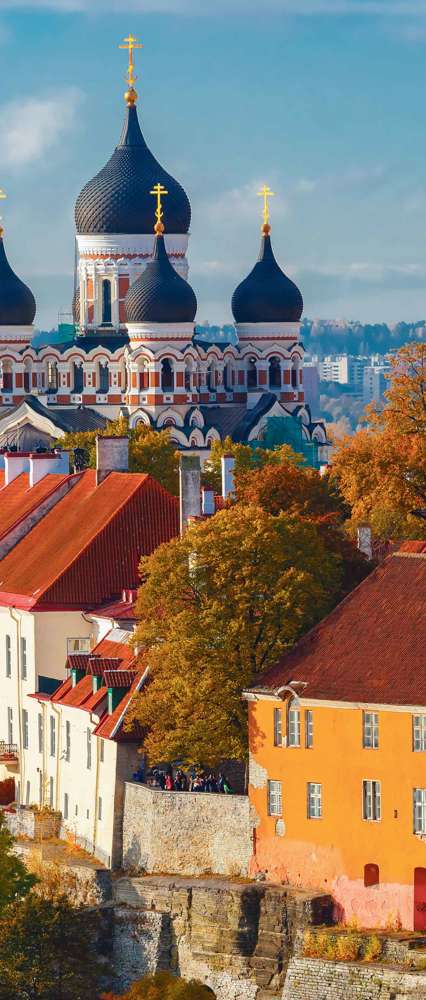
[58,417,179,496]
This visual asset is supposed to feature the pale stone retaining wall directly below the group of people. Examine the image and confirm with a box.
[123,782,252,877]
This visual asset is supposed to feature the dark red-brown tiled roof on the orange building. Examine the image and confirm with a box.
[252,543,426,705]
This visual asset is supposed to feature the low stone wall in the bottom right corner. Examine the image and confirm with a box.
[282,958,426,1000]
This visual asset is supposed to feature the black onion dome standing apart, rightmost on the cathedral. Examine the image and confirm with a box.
[231,235,303,323]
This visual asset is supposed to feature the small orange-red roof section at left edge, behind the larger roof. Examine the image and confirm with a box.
[0,469,70,538]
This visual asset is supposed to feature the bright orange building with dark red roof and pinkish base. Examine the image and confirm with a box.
[245,542,426,931]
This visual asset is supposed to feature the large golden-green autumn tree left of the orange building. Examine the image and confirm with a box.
[129,505,342,766]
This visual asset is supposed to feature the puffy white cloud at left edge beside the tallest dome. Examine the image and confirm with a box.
[0,87,83,167]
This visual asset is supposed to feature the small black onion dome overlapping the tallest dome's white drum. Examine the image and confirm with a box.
[125,232,197,323]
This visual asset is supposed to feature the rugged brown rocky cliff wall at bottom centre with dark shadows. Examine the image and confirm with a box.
[112,876,332,1000]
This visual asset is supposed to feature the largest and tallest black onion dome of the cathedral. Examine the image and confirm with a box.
[75,106,191,235]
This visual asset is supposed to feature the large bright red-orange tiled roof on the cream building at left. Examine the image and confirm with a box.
[0,469,179,610]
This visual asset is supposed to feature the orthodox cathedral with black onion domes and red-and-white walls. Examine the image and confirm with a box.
[0,35,327,460]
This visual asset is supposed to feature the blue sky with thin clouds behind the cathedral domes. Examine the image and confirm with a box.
[0,0,426,329]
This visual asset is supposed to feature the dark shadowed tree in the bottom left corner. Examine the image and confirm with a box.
[0,892,105,1000]
